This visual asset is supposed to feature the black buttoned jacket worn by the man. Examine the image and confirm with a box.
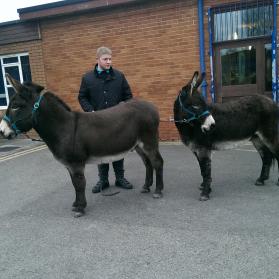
[78,66,133,111]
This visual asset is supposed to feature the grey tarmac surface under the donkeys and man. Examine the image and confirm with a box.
[0,138,279,279]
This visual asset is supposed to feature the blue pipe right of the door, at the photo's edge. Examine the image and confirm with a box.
[271,0,278,103]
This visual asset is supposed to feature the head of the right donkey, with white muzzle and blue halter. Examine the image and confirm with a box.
[177,72,215,132]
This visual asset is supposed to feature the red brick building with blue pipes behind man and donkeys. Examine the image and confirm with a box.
[0,0,277,140]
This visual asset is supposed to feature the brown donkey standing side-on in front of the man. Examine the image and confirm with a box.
[0,74,163,217]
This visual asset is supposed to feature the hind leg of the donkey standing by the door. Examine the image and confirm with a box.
[251,135,274,186]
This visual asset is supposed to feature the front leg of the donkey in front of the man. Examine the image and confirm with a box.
[68,166,87,217]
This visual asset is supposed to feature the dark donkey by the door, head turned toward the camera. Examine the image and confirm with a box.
[174,72,279,201]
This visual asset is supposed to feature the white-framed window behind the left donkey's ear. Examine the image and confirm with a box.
[0,53,32,109]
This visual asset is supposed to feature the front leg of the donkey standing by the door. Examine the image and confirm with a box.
[194,148,212,201]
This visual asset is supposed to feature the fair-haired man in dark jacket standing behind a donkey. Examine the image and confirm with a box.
[78,47,133,193]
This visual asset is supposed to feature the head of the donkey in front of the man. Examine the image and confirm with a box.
[0,74,44,138]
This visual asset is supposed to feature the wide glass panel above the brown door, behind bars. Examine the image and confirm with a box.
[213,3,272,42]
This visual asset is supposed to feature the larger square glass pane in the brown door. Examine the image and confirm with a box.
[220,46,256,86]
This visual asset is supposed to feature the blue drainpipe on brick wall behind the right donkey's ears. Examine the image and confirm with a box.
[198,0,207,99]
